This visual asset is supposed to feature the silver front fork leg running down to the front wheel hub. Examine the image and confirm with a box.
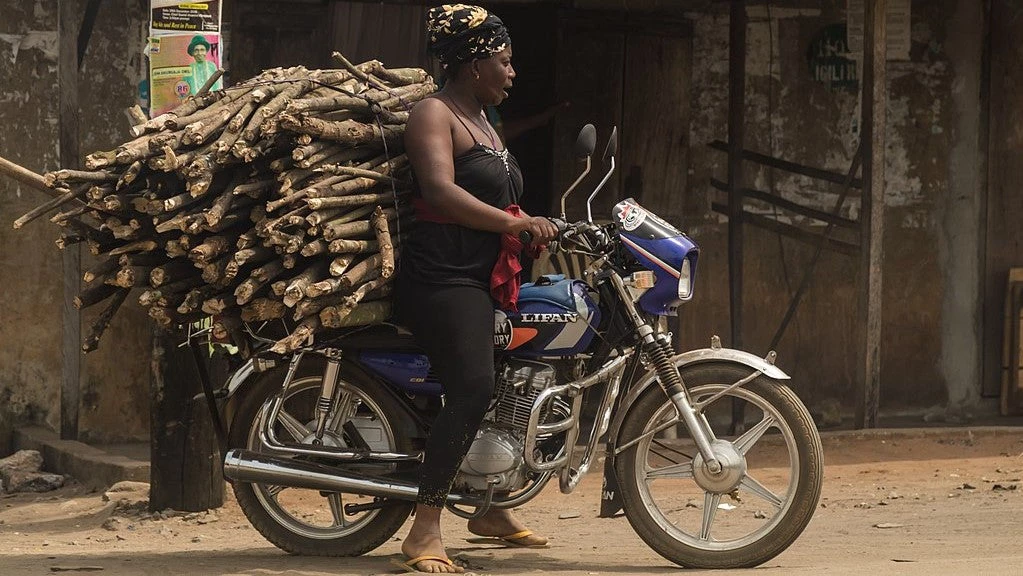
[609,274,721,474]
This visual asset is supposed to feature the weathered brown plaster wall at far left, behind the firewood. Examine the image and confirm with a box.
[0,0,149,441]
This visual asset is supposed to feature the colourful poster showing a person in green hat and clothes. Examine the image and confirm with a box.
[149,34,223,117]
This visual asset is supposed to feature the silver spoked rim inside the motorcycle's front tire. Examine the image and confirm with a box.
[634,385,800,551]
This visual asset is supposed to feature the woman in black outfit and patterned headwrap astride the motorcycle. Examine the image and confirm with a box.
[396,4,557,573]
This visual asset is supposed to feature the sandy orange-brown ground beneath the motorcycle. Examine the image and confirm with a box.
[0,429,1023,576]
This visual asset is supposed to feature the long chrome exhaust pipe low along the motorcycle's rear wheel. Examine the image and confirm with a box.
[224,448,480,505]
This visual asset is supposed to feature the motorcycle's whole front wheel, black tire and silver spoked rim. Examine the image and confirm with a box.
[615,363,824,568]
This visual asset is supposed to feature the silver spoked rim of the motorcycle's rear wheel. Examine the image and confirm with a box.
[247,376,396,540]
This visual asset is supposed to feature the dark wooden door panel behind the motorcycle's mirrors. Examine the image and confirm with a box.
[552,10,693,222]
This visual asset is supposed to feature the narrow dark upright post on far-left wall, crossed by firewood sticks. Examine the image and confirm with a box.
[57,0,82,440]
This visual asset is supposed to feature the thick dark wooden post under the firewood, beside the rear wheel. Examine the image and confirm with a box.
[149,328,224,512]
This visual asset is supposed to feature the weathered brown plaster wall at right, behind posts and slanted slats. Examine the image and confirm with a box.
[576,0,985,415]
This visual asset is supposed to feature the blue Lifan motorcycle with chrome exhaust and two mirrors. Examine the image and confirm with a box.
[213,125,822,568]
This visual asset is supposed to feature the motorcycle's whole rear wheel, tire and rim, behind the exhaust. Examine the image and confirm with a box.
[230,359,412,557]
